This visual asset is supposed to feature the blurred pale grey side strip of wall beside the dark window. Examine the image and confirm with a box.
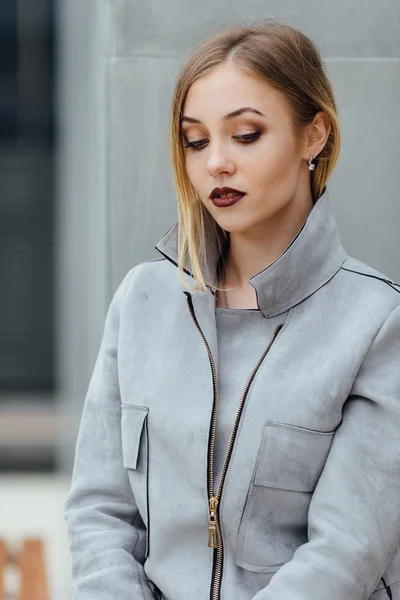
[56,0,112,471]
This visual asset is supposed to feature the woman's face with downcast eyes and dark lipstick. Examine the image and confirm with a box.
[181,62,311,232]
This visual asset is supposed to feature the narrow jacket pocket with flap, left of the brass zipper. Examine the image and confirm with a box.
[121,404,150,557]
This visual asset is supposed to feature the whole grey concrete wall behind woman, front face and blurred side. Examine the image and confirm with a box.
[59,0,400,465]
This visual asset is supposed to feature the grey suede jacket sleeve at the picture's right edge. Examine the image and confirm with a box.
[253,306,400,600]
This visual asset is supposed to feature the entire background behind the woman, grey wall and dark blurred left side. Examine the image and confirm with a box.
[0,0,400,600]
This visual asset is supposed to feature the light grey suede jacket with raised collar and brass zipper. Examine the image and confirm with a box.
[65,192,400,600]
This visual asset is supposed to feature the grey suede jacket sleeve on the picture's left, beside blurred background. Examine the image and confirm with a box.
[64,270,153,600]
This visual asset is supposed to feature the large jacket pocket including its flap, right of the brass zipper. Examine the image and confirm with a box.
[236,421,335,573]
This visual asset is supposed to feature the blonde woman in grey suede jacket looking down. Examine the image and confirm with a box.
[65,22,400,600]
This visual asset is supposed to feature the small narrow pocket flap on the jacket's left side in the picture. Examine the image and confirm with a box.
[121,404,149,469]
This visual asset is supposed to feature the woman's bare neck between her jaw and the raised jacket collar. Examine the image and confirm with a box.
[225,190,313,288]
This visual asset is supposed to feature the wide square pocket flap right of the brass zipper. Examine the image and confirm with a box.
[254,421,335,492]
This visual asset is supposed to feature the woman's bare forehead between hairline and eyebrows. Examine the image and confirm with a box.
[182,62,290,122]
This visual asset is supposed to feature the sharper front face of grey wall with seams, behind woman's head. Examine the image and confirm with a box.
[107,0,400,285]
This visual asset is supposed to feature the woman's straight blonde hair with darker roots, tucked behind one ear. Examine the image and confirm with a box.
[169,20,340,291]
